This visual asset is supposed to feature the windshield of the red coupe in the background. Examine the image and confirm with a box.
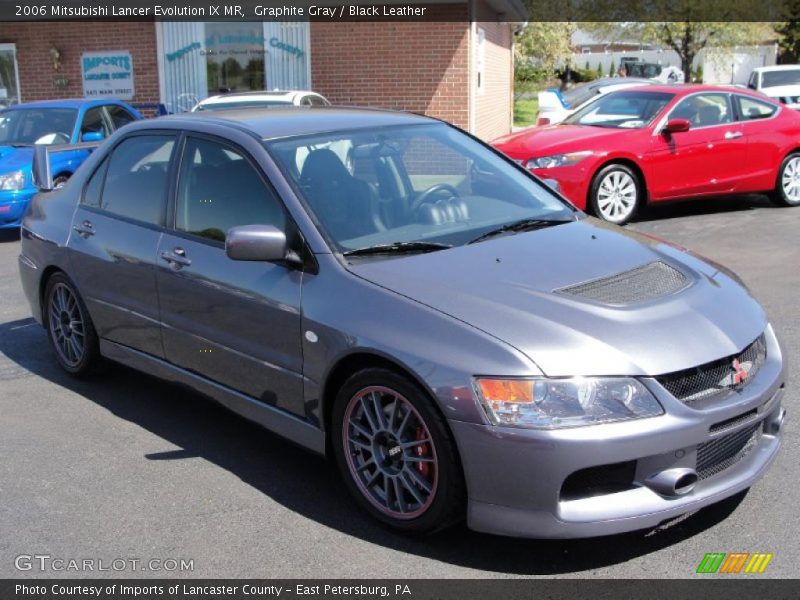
[564,90,675,129]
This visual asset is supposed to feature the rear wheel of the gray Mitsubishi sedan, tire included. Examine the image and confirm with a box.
[43,273,101,377]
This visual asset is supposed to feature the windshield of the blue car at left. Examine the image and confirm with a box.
[0,108,78,146]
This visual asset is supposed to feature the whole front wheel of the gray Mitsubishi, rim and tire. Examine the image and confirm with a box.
[331,368,466,534]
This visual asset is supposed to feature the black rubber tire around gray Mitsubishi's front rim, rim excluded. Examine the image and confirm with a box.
[330,368,465,534]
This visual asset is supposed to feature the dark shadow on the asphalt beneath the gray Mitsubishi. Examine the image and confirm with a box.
[0,318,744,575]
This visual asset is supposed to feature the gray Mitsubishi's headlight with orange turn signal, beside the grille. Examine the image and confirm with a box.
[475,377,664,429]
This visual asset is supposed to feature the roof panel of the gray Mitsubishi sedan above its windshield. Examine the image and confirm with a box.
[131,106,438,140]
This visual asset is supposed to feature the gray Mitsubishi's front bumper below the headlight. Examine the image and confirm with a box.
[450,328,786,538]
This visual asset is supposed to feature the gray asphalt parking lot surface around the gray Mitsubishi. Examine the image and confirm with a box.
[0,196,800,578]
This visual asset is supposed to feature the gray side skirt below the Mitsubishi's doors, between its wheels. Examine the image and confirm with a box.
[100,339,325,455]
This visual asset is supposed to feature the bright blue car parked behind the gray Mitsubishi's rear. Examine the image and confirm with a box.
[0,99,142,229]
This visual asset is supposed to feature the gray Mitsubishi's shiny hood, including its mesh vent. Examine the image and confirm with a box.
[349,218,767,376]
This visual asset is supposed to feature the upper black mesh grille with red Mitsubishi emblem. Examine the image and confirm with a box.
[656,335,767,404]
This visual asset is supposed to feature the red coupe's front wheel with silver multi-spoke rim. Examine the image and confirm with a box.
[589,164,644,225]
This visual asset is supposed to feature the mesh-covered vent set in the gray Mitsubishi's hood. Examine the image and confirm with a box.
[555,261,689,306]
